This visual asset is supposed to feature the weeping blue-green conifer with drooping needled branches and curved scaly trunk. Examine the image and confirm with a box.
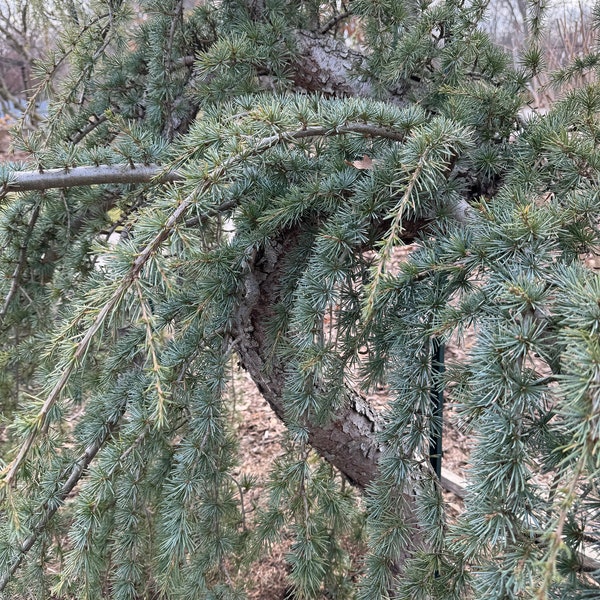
[0,0,600,600]
